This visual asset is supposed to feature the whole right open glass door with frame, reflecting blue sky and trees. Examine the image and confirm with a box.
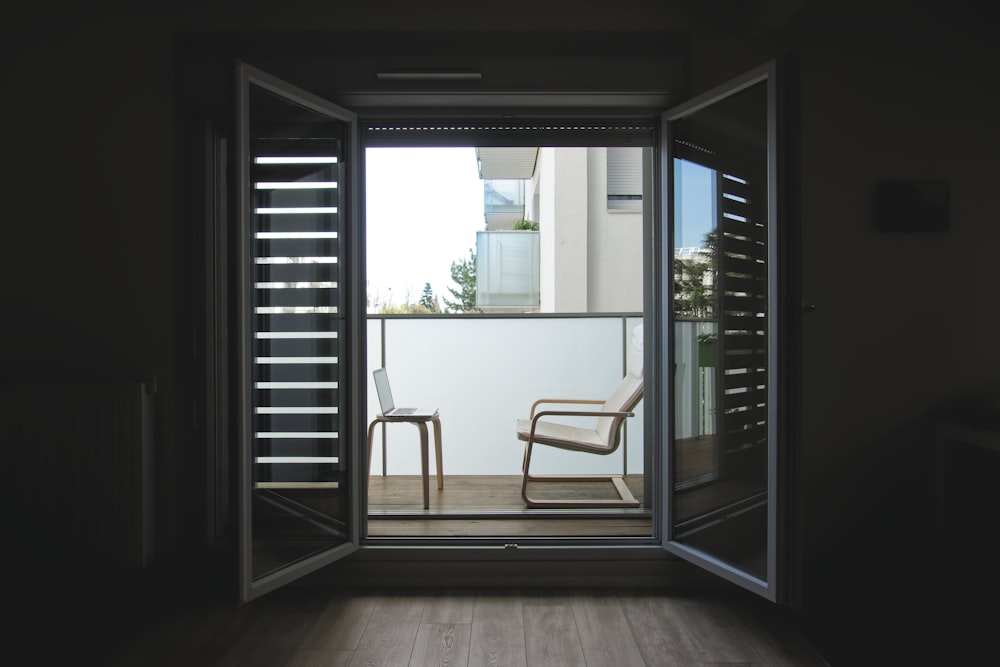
[661,65,781,601]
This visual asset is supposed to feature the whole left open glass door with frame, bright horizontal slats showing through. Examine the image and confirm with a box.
[235,64,362,601]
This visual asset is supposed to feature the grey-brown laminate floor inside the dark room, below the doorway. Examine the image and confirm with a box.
[95,587,827,667]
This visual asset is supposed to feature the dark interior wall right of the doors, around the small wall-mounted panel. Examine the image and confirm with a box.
[797,4,1000,656]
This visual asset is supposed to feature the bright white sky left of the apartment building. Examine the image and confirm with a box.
[365,147,486,306]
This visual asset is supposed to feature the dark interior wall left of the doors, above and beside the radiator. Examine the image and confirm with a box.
[0,13,190,553]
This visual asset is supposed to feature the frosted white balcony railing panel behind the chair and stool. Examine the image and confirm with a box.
[368,315,643,475]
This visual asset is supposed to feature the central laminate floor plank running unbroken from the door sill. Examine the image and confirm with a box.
[469,591,528,667]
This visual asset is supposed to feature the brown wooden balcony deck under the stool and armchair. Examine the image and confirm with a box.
[368,475,653,537]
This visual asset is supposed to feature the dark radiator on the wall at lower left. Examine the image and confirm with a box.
[0,380,155,568]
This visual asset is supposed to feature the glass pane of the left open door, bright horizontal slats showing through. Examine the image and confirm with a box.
[245,85,350,579]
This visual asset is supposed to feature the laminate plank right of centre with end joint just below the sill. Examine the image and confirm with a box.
[524,604,587,667]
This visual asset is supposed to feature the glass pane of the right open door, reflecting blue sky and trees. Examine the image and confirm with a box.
[670,82,770,581]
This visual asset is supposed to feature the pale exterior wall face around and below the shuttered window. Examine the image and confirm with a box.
[587,148,642,313]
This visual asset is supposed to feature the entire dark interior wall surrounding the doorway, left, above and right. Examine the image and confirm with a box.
[0,0,1000,656]
